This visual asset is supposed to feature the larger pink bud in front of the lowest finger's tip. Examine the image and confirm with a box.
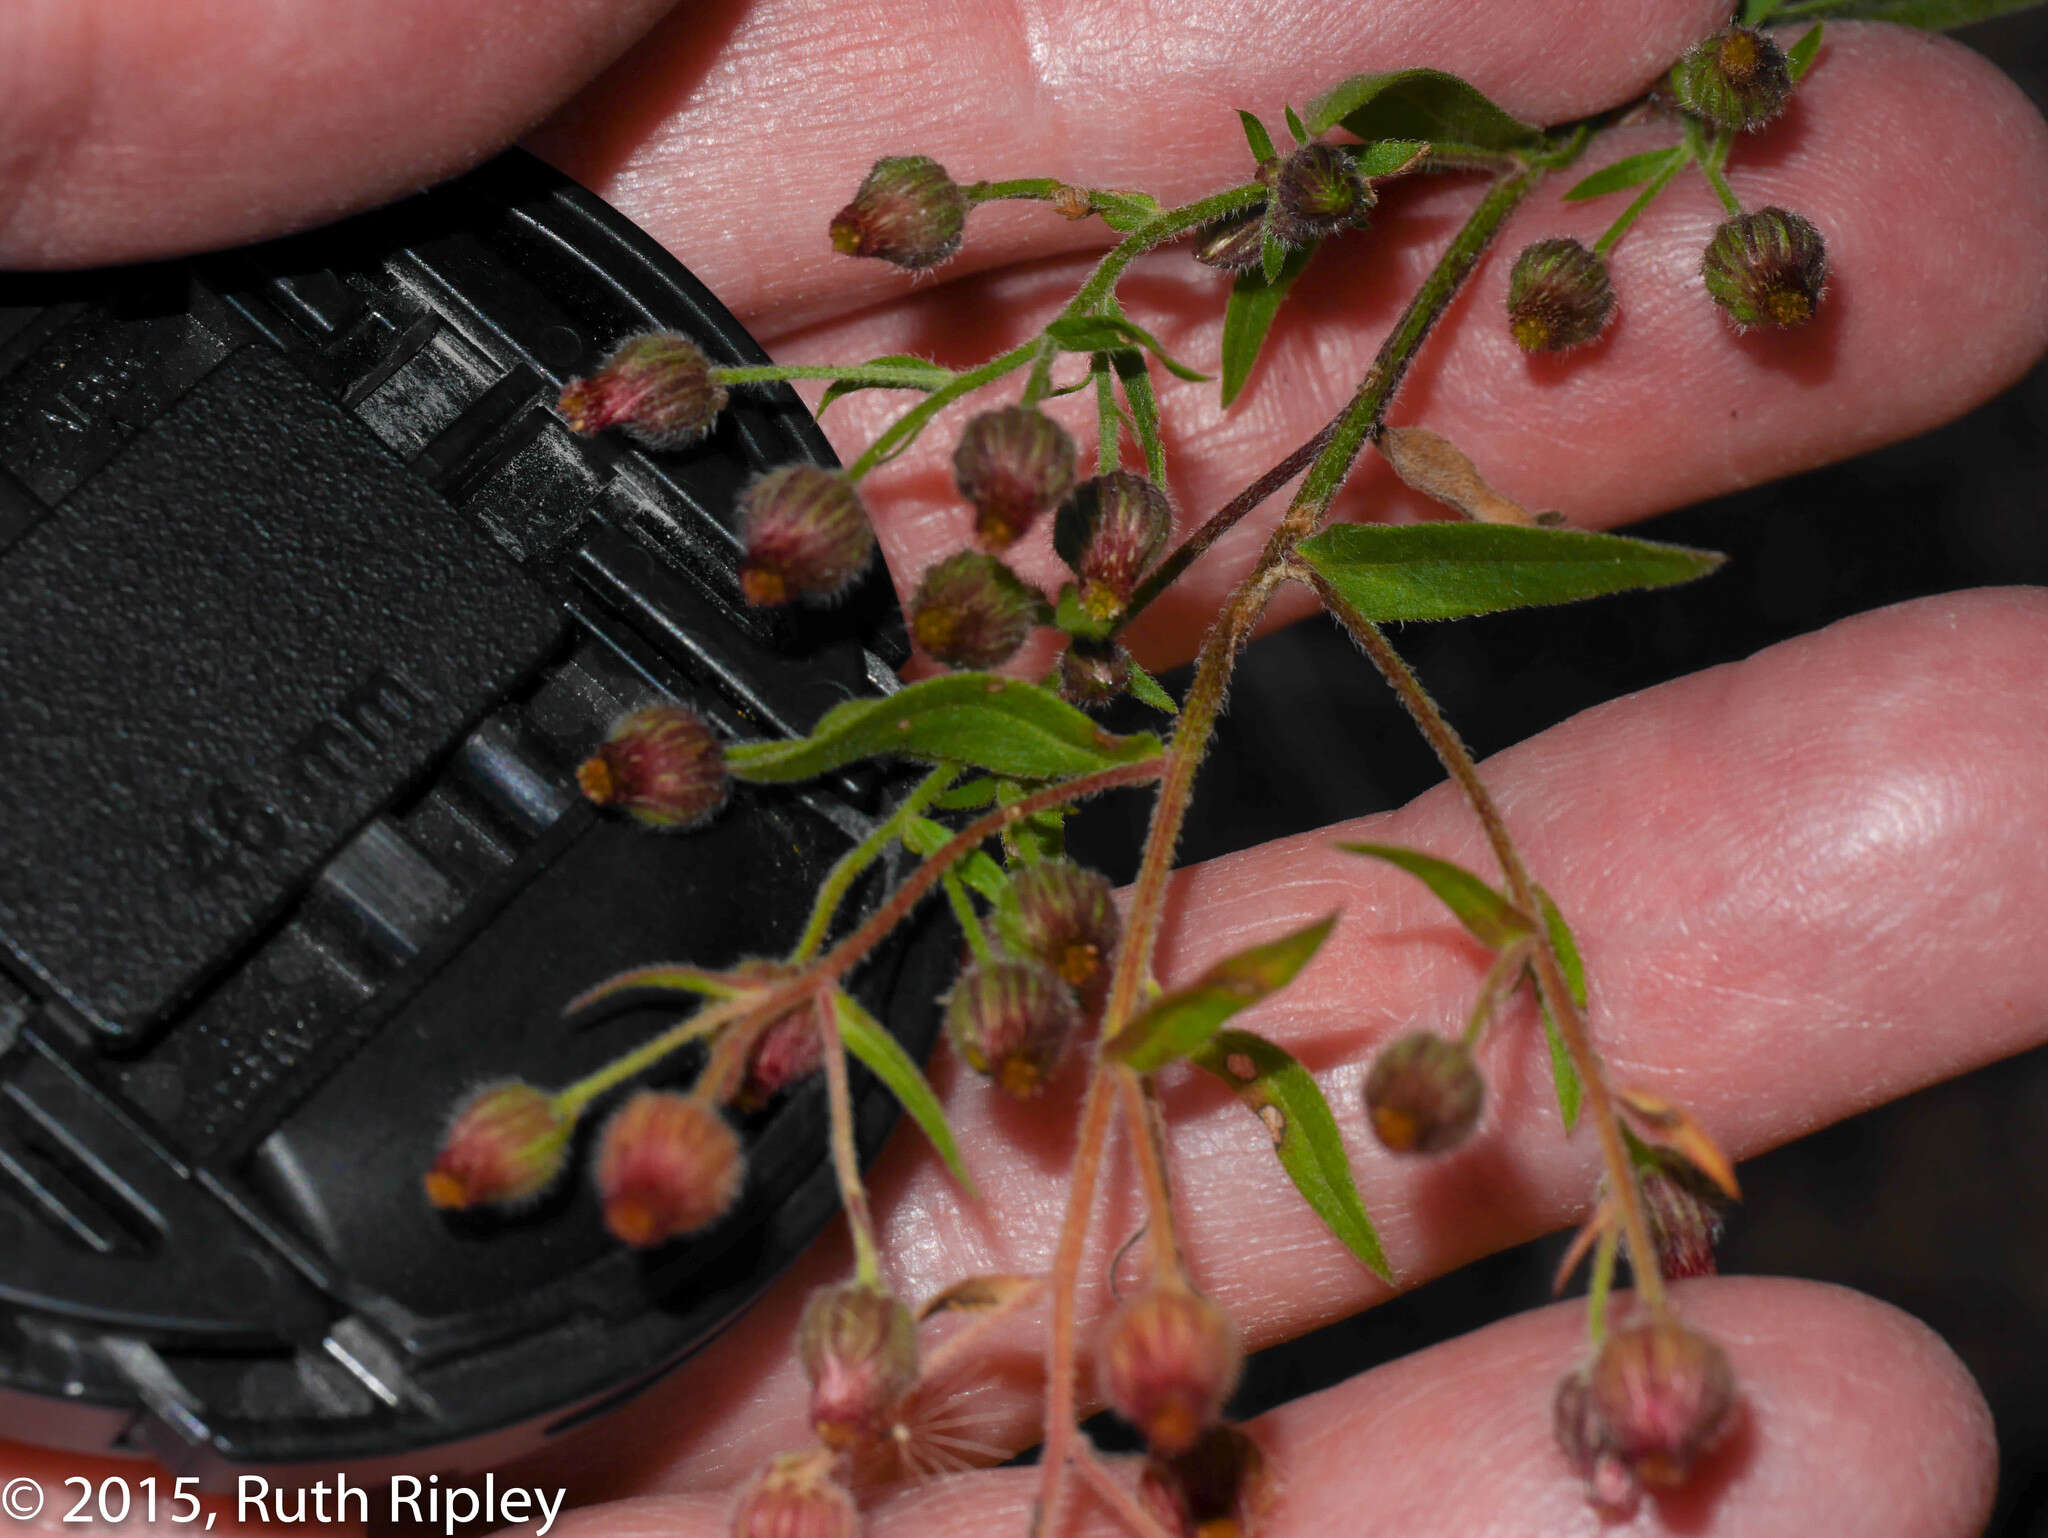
[1587,1319,1735,1485]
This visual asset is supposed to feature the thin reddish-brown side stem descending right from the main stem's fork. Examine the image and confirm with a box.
[1303,593,1665,1313]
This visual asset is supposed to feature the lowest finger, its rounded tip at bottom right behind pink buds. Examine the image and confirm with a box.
[540,1278,1997,1538]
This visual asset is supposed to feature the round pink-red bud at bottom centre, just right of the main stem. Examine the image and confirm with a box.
[1096,1284,1245,1456]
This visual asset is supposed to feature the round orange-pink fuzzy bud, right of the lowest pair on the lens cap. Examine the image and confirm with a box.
[596,1090,745,1249]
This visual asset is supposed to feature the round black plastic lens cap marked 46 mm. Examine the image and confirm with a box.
[0,154,956,1479]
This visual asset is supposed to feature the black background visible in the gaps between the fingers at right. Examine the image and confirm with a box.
[1090,12,2048,1538]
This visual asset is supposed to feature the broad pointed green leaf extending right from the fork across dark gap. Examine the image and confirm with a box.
[1300,522,1724,623]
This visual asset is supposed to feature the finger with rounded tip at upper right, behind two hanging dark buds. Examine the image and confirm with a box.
[756,25,2048,666]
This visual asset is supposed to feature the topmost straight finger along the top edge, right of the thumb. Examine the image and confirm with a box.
[535,0,1726,334]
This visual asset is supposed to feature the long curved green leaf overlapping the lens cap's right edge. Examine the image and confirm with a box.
[725,674,1159,784]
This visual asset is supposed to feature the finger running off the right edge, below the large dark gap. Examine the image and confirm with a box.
[499,592,2048,1493]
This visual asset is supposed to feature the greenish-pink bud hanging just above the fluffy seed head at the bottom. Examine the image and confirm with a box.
[797,1282,918,1450]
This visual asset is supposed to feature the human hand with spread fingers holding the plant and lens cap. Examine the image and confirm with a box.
[0,0,2048,1532]
